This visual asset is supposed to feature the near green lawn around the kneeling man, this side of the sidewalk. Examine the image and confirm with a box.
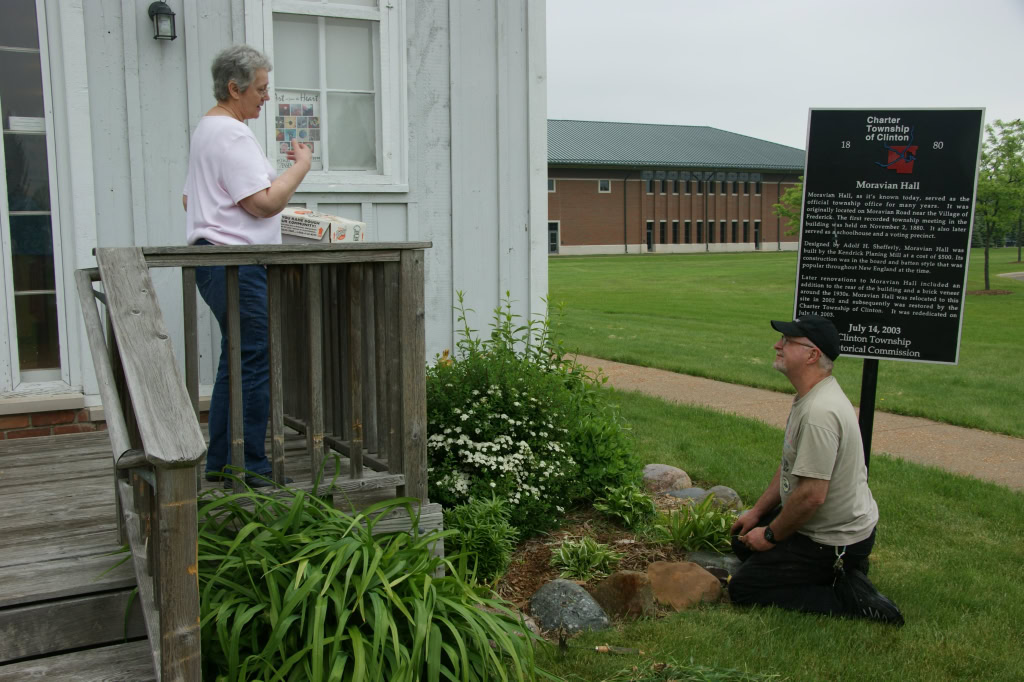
[539,387,1024,682]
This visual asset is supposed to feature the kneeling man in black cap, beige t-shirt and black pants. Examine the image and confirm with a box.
[729,315,903,625]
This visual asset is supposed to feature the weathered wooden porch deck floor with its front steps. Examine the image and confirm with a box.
[0,425,440,682]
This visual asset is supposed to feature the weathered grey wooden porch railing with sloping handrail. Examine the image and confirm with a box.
[76,243,430,681]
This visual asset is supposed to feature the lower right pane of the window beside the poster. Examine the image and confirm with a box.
[327,93,377,170]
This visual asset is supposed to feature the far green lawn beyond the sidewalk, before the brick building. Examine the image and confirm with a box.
[549,249,1024,436]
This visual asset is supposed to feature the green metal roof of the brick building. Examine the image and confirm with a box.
[548,120,804,172]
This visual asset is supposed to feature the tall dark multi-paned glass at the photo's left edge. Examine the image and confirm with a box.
[0,0,63,388]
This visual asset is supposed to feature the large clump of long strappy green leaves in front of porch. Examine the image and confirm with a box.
[199,491,546,682]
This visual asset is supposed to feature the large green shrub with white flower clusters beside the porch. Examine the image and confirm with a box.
[427,292,639,535]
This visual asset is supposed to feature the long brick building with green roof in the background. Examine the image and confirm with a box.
[548,120,804,255]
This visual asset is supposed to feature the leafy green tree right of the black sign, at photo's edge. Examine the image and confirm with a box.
[975,119,1024,291]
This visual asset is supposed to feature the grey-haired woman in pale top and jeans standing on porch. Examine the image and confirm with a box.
[181,45,312,486]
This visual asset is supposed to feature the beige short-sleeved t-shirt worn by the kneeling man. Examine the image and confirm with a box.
[779,377,879,546]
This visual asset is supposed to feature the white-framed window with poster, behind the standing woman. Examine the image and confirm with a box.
[266,0,408,191]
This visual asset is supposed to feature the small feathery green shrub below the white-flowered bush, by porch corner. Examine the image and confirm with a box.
[444,497,518,581]
